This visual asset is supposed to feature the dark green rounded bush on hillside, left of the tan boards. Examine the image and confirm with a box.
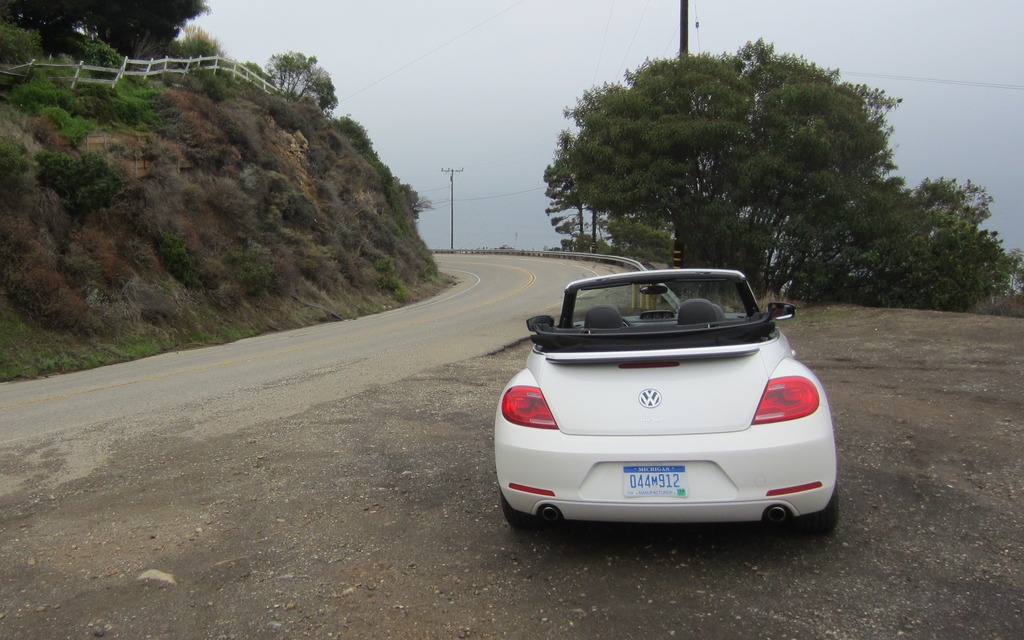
[36,151,124,220]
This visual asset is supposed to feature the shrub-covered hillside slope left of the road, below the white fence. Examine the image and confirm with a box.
[0,73,442,380]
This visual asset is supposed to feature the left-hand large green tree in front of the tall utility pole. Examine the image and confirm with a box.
[549,55,750,266]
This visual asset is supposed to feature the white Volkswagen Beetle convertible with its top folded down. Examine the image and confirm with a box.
[495,269,839,534]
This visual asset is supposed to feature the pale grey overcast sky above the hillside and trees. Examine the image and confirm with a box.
[198,0,1024,250]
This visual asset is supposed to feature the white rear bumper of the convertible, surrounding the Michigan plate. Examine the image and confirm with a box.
[495,411,837,522]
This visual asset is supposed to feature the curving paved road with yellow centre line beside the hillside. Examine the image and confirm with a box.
[0,255,607,444]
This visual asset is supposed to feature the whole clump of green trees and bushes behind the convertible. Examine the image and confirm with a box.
[545,42,1024,316]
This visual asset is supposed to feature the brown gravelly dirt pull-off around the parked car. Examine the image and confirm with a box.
[0,307,1024,640]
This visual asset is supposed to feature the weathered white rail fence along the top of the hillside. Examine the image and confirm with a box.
[0,55,278,93]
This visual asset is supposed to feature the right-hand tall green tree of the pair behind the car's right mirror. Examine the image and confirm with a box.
[732,41,902,297]
